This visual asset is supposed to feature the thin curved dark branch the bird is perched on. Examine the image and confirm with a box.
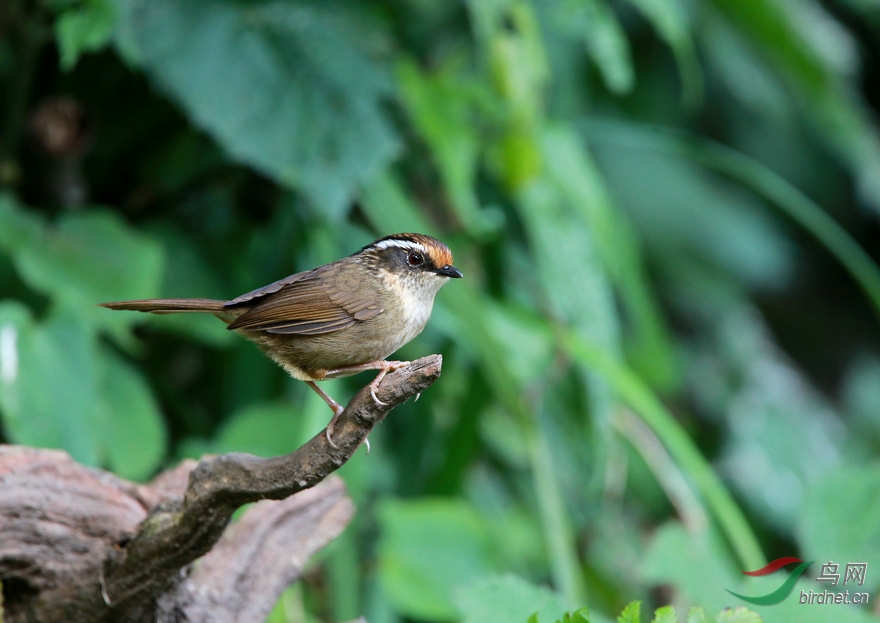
[104,355,443,620]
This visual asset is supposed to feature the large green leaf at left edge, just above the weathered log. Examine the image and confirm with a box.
[0,301,165,479]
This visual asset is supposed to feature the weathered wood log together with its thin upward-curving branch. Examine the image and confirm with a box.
[0,355,442,623]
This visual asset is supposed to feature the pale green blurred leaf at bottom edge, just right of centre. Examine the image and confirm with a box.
[455,574,565,623]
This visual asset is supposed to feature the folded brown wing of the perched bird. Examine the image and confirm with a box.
[228,266,383,335]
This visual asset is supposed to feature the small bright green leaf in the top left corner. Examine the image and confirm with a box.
[55,0,117,71]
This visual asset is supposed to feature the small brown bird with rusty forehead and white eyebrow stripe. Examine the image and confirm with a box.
[101,234,462,447]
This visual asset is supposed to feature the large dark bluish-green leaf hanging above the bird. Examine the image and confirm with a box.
[122,0,397,217]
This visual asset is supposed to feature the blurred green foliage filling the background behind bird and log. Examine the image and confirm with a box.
[0,0,880,623]
